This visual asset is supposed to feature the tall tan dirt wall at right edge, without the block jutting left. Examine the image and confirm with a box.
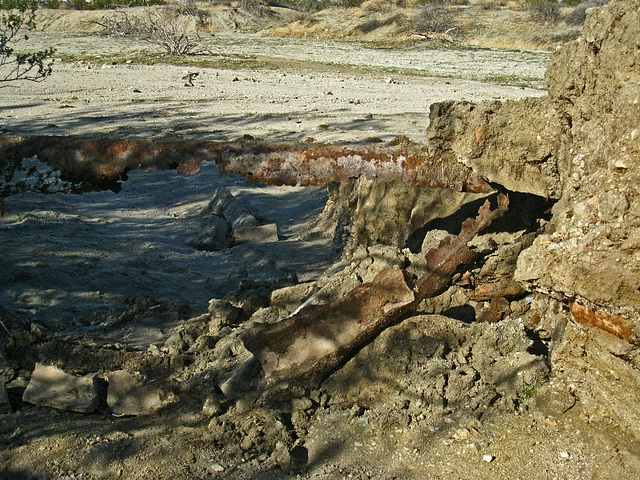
[516,0,640,318]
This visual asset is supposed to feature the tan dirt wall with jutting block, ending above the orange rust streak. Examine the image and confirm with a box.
[429,0,640,341]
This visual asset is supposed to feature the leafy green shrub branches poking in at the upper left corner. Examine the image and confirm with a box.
[0,0,55,82]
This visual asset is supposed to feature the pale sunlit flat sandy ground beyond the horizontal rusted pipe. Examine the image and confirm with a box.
[0,33,549,142]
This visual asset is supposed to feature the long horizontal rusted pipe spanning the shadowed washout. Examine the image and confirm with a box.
[0,136,493,193]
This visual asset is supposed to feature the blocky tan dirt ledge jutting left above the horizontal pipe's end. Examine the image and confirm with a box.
[428,98,568,199]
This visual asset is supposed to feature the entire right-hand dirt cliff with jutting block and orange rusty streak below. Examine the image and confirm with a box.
[418,0,640,435]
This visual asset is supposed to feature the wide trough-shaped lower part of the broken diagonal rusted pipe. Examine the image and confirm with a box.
[242,267,415,386]
